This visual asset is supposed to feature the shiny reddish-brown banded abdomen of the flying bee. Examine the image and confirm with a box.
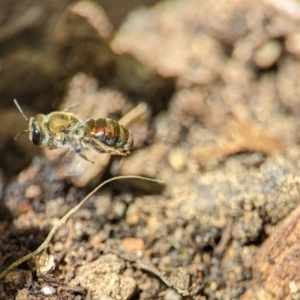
[85,119,133,150]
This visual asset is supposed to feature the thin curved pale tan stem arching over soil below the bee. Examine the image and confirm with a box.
[0,175,164,279]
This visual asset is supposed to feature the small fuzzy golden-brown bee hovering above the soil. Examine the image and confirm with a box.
[14,99,133,162]
